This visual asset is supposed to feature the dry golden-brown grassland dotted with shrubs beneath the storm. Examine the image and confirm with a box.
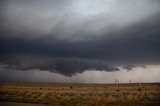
[0,83,160,105]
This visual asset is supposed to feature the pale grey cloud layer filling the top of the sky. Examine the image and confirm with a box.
[1,0,160,41]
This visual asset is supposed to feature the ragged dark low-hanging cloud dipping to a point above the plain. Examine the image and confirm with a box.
[1,55,119,76]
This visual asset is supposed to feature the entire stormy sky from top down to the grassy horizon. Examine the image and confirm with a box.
[0,0,160,83]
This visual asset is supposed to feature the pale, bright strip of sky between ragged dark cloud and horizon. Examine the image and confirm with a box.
[0,65,160,83]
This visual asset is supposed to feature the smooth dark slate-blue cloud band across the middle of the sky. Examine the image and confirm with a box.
[1,12,160,63]
